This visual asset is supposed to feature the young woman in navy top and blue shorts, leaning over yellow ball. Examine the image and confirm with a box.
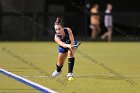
[52,17,77,78]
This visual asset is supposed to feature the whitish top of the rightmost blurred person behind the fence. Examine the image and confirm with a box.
[104,10,113,27]
